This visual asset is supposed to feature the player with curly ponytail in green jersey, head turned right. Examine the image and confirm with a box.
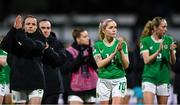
[140,17,176,104]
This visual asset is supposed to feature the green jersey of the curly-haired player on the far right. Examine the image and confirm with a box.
[140,35,173,84]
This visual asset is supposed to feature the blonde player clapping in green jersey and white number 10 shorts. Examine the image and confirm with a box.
[93,19,129,105]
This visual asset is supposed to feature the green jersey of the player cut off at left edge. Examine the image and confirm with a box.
[0,49,10,84]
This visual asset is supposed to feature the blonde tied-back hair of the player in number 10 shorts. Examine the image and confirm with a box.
[99,19,115,40]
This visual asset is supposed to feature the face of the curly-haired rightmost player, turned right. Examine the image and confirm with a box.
[157,20,167,37]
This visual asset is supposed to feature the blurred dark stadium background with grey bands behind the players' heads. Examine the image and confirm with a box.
[0,0,180,47]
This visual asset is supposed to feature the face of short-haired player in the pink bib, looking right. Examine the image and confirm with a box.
[77,31,89,45]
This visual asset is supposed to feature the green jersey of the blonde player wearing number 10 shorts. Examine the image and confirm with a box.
[93,39,128,79]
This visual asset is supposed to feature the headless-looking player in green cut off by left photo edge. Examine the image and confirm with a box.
[0,49,10,104]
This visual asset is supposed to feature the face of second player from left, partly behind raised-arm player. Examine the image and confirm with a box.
[39,21,51,38]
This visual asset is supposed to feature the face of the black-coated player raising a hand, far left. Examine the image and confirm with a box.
[24,17,37,33]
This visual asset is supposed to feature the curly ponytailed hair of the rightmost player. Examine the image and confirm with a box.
[141,16,165,37]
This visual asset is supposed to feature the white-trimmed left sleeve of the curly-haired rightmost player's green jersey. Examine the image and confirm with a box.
[140,38,149,54]
